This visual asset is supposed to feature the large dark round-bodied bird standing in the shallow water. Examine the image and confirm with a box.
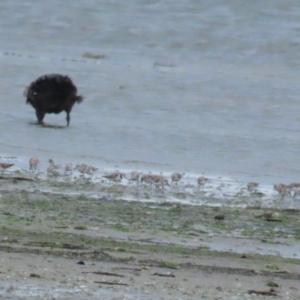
[24,74,83,126]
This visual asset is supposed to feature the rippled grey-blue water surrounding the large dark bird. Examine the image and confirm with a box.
[0,0,300,190]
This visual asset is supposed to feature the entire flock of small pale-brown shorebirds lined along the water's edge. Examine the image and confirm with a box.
[0,157,300,199]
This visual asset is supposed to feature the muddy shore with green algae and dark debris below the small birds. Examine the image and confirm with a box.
[0,177,300,299]
